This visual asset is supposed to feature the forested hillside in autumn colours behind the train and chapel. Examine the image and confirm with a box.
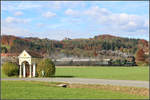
[1,35,149,65]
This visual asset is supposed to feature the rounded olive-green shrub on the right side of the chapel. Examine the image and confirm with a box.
[37,59,55,77]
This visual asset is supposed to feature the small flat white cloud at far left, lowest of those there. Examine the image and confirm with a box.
[5,17,31,24]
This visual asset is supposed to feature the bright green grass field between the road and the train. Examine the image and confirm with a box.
[55,67,149,81]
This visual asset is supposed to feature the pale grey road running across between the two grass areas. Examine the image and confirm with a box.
[1,78,149,88]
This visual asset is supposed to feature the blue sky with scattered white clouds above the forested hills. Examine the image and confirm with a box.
[1,1,149,40]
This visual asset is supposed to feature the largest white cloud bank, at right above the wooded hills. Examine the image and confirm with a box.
[84,6,148,32]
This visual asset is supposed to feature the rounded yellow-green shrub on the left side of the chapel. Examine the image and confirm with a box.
[2,62,19,76]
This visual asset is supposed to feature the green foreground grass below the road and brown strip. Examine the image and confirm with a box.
[1,81,148,99]
